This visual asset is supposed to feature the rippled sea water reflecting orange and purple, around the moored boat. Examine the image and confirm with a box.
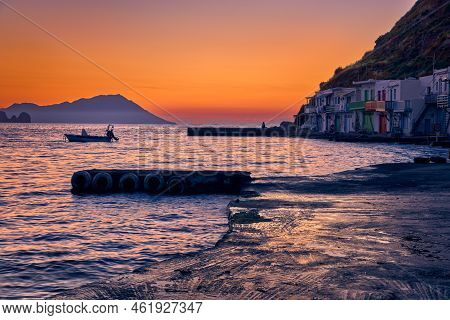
[0,124,447,299]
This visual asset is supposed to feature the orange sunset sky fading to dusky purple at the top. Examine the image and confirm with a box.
[0,0,415,123]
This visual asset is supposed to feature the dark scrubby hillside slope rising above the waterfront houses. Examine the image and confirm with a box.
[320,0,450,89]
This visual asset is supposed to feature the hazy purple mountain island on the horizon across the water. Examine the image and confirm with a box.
[3,95,174,124]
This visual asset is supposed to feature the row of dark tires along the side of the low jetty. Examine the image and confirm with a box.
[71,171,187,195]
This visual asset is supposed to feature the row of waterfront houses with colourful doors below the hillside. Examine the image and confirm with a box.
[296,67,450,136]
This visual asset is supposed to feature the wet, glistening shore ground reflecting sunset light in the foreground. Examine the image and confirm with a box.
[58,164,450,299]
